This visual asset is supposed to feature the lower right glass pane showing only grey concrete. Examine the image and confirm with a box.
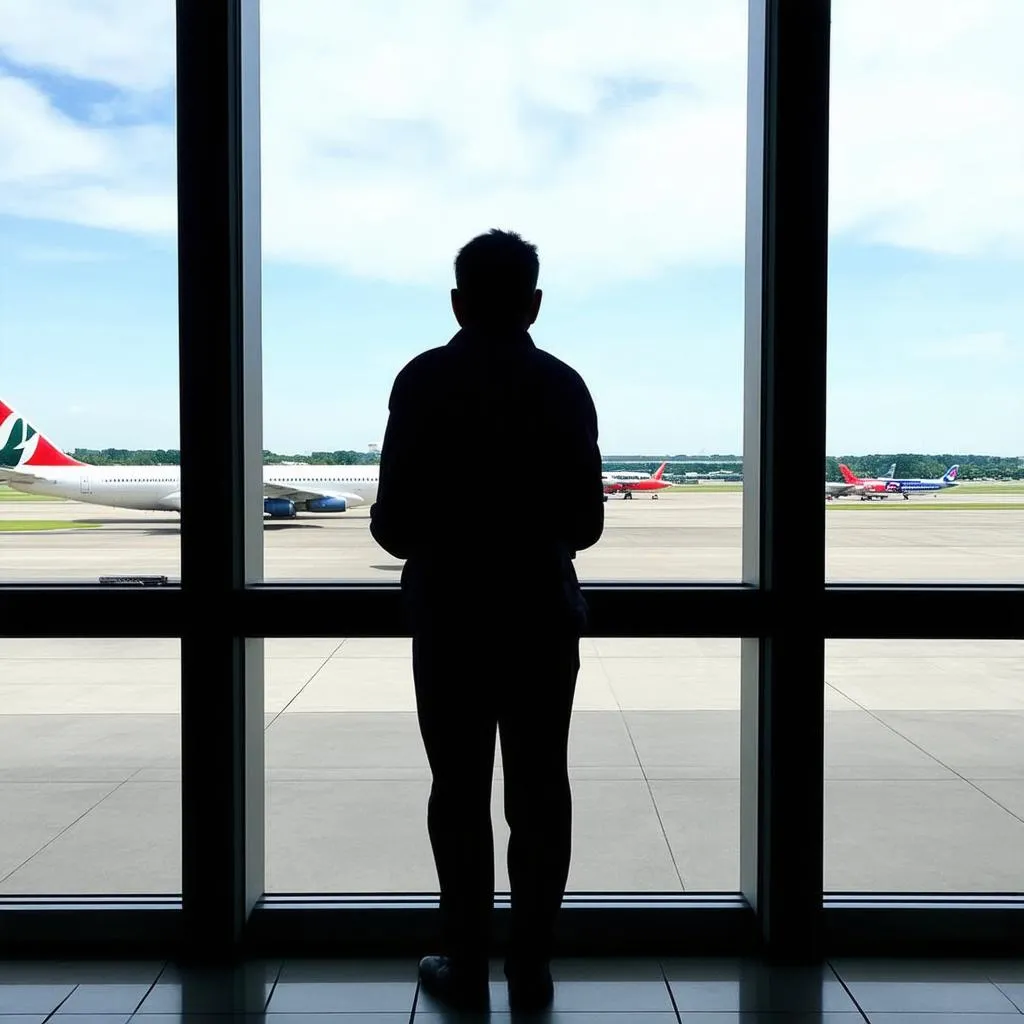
[824,640,1024,893]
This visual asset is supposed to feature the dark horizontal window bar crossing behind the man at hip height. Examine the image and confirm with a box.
[0,583,1024,640]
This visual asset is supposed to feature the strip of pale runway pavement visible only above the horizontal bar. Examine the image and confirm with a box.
[0,487,1024,582]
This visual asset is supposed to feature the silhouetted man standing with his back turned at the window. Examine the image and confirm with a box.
[370,230,604,1009]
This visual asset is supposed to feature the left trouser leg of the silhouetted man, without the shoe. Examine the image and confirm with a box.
[413,634,497,972]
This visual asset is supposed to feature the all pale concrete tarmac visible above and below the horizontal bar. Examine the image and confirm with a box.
[0,488,1024,895]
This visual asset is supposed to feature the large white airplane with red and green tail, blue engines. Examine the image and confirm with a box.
[0,401,379,519]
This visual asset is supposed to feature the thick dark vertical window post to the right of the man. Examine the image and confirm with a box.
[741,0,829,956]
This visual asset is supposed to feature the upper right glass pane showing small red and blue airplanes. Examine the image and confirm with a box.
[825,0,1024,582]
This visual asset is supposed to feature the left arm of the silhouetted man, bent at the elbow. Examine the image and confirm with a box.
[370,369,420,558]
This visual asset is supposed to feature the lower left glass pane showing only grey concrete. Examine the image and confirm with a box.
[0,638,181,896]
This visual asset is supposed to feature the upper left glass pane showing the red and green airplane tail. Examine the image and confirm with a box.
[0,0,181,581]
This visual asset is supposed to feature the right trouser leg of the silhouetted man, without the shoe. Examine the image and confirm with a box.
[499,634,580,973]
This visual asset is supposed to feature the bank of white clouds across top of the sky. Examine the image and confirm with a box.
[0,0,1024,287]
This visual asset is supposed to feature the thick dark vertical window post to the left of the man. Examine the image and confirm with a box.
[177,0,263,958]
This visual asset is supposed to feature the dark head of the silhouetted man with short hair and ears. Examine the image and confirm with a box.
[452,228,541,329]
